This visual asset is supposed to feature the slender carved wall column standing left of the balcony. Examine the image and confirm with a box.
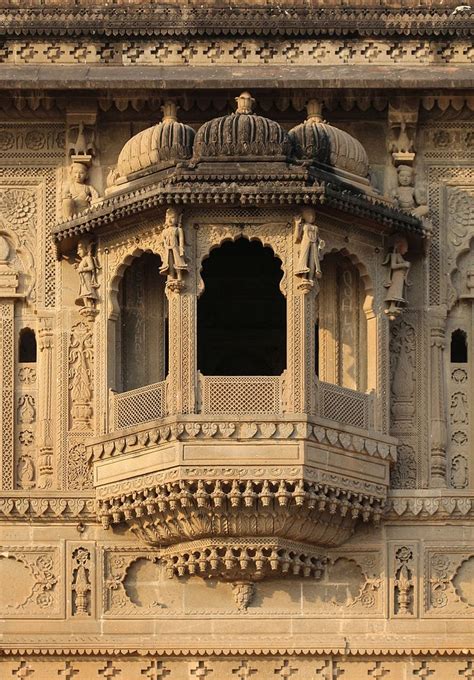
[38,317,53,489]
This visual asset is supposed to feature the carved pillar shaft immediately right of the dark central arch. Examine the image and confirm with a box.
[287,284,319,413]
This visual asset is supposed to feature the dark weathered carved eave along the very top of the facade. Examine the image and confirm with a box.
[0,6,474,39]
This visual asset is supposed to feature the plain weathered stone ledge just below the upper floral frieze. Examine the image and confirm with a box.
[0,64,474,94]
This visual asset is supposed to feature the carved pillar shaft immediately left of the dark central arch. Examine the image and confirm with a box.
[166,286,196,413]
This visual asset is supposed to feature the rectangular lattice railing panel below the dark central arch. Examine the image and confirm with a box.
[199,375,282,415]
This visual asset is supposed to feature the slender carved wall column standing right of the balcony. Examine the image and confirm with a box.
[430,310,447,488]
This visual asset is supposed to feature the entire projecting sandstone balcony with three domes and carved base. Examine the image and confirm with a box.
[50,93,425,590]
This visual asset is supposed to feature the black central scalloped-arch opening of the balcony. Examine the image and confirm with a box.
[198,238,286,376]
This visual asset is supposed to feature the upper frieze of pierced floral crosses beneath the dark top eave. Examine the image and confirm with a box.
[0,39,474,68]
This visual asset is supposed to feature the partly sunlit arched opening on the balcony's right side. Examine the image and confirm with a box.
[315,253,368,392]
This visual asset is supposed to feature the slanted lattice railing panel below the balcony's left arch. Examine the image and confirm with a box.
[111,380,166,430]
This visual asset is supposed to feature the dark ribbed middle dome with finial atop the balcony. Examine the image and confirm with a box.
[193,92,290,160]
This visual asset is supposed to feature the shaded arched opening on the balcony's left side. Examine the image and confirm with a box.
[117,253,168,392]
